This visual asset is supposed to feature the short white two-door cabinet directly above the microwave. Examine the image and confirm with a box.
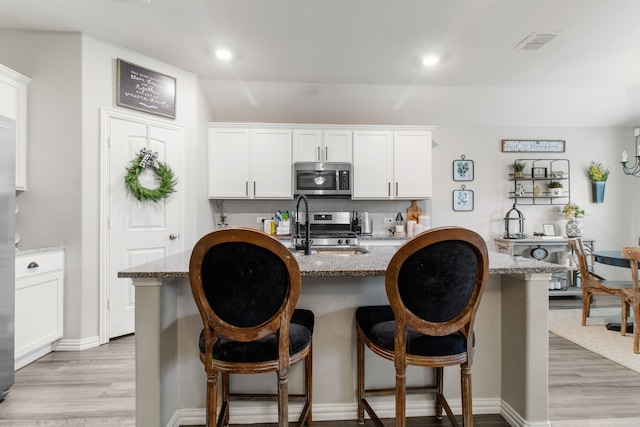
[293,129,353,163]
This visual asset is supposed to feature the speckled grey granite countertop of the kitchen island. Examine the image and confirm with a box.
[118,246,567,279]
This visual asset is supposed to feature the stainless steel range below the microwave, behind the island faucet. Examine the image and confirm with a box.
[292,212,359,247]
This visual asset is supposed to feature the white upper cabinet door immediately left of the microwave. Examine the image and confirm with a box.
[249,129,293,199]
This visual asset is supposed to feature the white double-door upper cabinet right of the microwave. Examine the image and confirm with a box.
[353,130,432,199]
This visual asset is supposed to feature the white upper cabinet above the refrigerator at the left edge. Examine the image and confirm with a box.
[0,65,31,190]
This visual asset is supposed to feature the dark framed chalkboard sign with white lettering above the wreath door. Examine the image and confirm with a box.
[116,58,176,119]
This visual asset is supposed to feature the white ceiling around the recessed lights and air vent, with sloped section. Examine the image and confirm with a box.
[0,0,640,126]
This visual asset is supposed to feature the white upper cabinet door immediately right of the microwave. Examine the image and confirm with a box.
[353,131,393,199]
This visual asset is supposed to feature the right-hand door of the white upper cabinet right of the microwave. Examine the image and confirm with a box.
[393,131,432,199]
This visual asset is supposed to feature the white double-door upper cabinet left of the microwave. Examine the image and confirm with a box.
[209,125,293,199]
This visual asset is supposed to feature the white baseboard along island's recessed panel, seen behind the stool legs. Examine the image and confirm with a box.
[166,396,502,427]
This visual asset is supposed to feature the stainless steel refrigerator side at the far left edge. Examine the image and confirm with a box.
[0,116,16,401]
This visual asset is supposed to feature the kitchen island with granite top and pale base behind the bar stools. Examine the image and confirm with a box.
[118,246,565,427]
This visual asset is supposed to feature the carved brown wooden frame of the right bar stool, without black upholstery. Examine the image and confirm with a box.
[356,227,489,427]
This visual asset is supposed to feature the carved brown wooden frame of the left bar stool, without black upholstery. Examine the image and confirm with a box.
[189,227,312,427]
